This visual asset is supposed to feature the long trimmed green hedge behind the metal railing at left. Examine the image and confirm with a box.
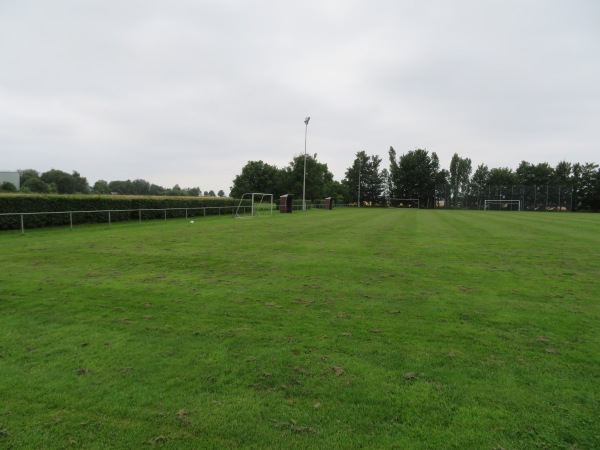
[0,194,246,230]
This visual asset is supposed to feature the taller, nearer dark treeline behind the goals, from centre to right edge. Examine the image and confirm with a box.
[231,147,600,211]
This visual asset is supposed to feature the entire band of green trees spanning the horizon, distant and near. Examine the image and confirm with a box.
[5,147,600,210]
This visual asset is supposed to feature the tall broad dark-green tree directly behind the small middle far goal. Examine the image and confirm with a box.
[390,148,440,207]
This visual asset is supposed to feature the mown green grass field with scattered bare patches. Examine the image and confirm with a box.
[0,208,600,449]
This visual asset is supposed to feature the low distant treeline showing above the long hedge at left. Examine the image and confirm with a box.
[0,169,225,197]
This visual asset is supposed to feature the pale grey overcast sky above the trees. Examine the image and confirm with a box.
[0,0,600,193]
